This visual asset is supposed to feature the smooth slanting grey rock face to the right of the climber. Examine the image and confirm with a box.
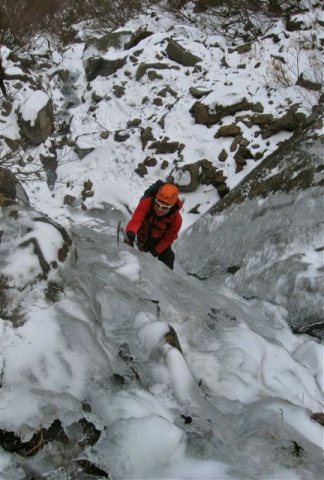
[178,107,324,338]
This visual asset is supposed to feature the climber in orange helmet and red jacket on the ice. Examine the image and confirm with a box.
[125,183,182,270]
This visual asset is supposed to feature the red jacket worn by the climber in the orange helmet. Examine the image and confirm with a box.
[126,197,182,255]
